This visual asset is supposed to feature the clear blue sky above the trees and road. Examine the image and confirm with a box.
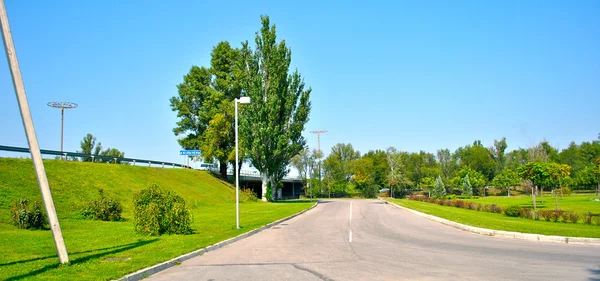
[0,0,600,165]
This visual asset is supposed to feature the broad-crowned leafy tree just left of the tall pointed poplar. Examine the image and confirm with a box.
[170,42,240,178]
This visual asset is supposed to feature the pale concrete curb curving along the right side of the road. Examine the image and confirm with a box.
[379,198,600,246]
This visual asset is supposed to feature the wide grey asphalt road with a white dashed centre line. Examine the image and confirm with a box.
[148,200,600,281]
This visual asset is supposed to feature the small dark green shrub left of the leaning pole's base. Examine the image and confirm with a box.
[10,199,46,229]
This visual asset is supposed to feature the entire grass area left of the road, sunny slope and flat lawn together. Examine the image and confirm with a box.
[0,158,312,280]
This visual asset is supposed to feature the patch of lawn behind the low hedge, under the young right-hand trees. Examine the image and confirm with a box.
[454,195,600,214]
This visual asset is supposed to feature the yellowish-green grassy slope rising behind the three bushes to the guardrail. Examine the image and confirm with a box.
[0,158,244,223]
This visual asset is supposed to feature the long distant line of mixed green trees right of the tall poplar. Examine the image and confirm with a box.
[292,136,600,197]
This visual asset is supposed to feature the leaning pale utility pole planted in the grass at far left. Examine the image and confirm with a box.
[0,0,69,263]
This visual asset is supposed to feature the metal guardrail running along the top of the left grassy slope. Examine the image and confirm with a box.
[0,145,191,169]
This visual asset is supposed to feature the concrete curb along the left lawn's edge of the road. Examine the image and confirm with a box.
[116,201,319,281]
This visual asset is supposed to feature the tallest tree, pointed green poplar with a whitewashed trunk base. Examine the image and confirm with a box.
[238,16,311,201]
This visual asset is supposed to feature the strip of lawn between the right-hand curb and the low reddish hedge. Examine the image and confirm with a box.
[388,199,600,238]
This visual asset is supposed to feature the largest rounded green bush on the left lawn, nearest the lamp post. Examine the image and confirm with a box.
[133,184,192,236]
